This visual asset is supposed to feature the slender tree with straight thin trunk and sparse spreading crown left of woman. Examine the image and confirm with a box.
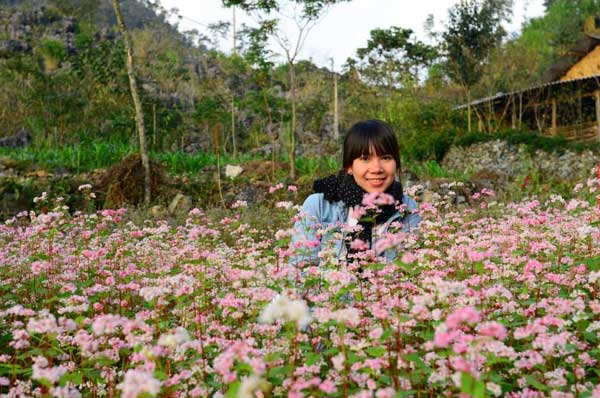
[223,0,349,179]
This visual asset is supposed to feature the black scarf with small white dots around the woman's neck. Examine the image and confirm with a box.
[313,170,403,254]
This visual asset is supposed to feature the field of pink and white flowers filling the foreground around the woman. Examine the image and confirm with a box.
[0,180,600,398]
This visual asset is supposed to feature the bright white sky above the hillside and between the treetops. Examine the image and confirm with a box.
[161,0,544,70]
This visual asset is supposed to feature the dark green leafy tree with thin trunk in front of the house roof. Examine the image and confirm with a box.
[442,0,512,132]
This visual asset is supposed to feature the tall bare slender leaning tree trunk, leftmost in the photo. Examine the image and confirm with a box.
[113,0,150,205]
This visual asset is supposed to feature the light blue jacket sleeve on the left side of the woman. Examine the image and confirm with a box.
[290,193,324,265]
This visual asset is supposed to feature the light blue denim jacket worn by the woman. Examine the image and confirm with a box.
[290,193,421,265]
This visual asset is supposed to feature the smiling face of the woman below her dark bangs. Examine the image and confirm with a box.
[347,148,397,193]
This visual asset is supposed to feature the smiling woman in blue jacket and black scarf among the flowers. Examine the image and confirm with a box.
[291,120,420,264]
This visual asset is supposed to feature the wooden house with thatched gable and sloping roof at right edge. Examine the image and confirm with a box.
[459,17,600,141]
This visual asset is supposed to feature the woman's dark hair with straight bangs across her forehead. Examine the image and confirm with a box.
[342,119,400,170]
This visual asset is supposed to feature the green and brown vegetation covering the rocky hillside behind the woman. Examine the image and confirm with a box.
[0,0,598,159]
